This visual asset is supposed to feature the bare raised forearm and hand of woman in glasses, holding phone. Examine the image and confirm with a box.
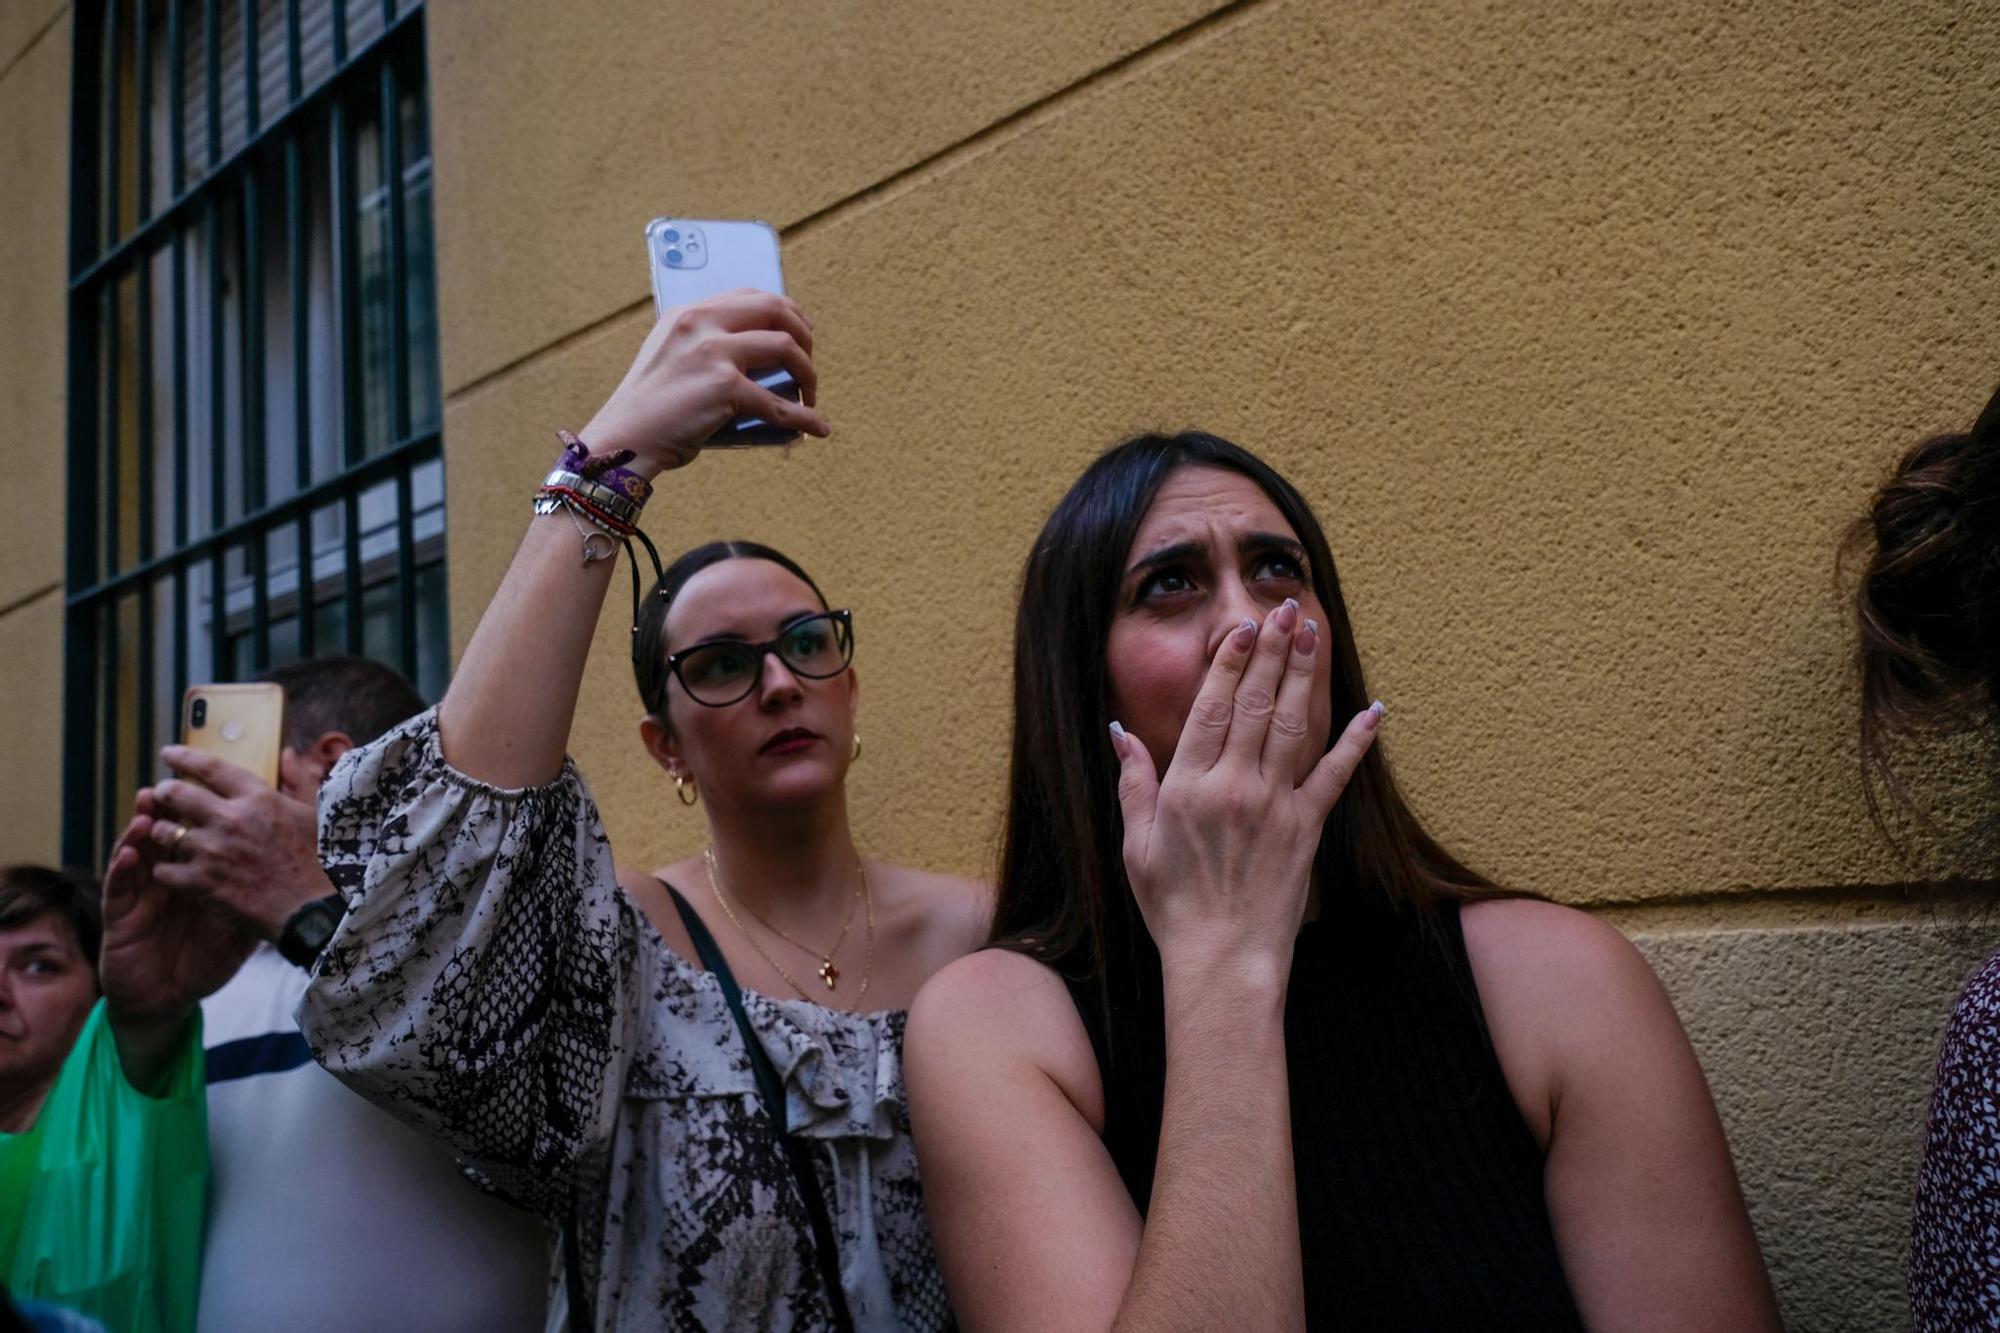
[438,290,828,787]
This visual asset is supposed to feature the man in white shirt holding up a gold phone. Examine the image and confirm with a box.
[120,656,546,1333]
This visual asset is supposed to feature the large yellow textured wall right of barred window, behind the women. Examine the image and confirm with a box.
[430,0,2000,1329]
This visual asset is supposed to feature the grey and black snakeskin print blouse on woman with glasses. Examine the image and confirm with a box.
[300,713,952,1329]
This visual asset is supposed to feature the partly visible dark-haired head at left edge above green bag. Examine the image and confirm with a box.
[0,865,100,1107]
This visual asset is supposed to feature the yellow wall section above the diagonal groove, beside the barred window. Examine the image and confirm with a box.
[428,0,1218,388]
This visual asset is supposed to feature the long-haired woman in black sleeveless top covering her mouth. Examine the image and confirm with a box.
[908,432,1778,1333]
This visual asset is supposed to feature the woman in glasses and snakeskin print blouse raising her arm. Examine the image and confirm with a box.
[302,292,986,1329]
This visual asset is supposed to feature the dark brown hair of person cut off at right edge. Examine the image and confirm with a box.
[1846,384,2000,845]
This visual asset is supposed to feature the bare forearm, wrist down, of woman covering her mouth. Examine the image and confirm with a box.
[1114,955,1304,1329]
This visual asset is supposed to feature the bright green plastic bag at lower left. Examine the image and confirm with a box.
[0,1001,208,1333]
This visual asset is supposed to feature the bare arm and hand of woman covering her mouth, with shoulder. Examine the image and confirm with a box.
[908,602,1378,1331]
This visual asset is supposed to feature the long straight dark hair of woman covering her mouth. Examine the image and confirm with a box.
[994,430,1504,1081]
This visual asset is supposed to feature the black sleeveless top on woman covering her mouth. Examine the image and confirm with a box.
[1070,895,1582,1329]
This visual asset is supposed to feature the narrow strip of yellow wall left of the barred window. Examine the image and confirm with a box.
[0,0,70,865]
